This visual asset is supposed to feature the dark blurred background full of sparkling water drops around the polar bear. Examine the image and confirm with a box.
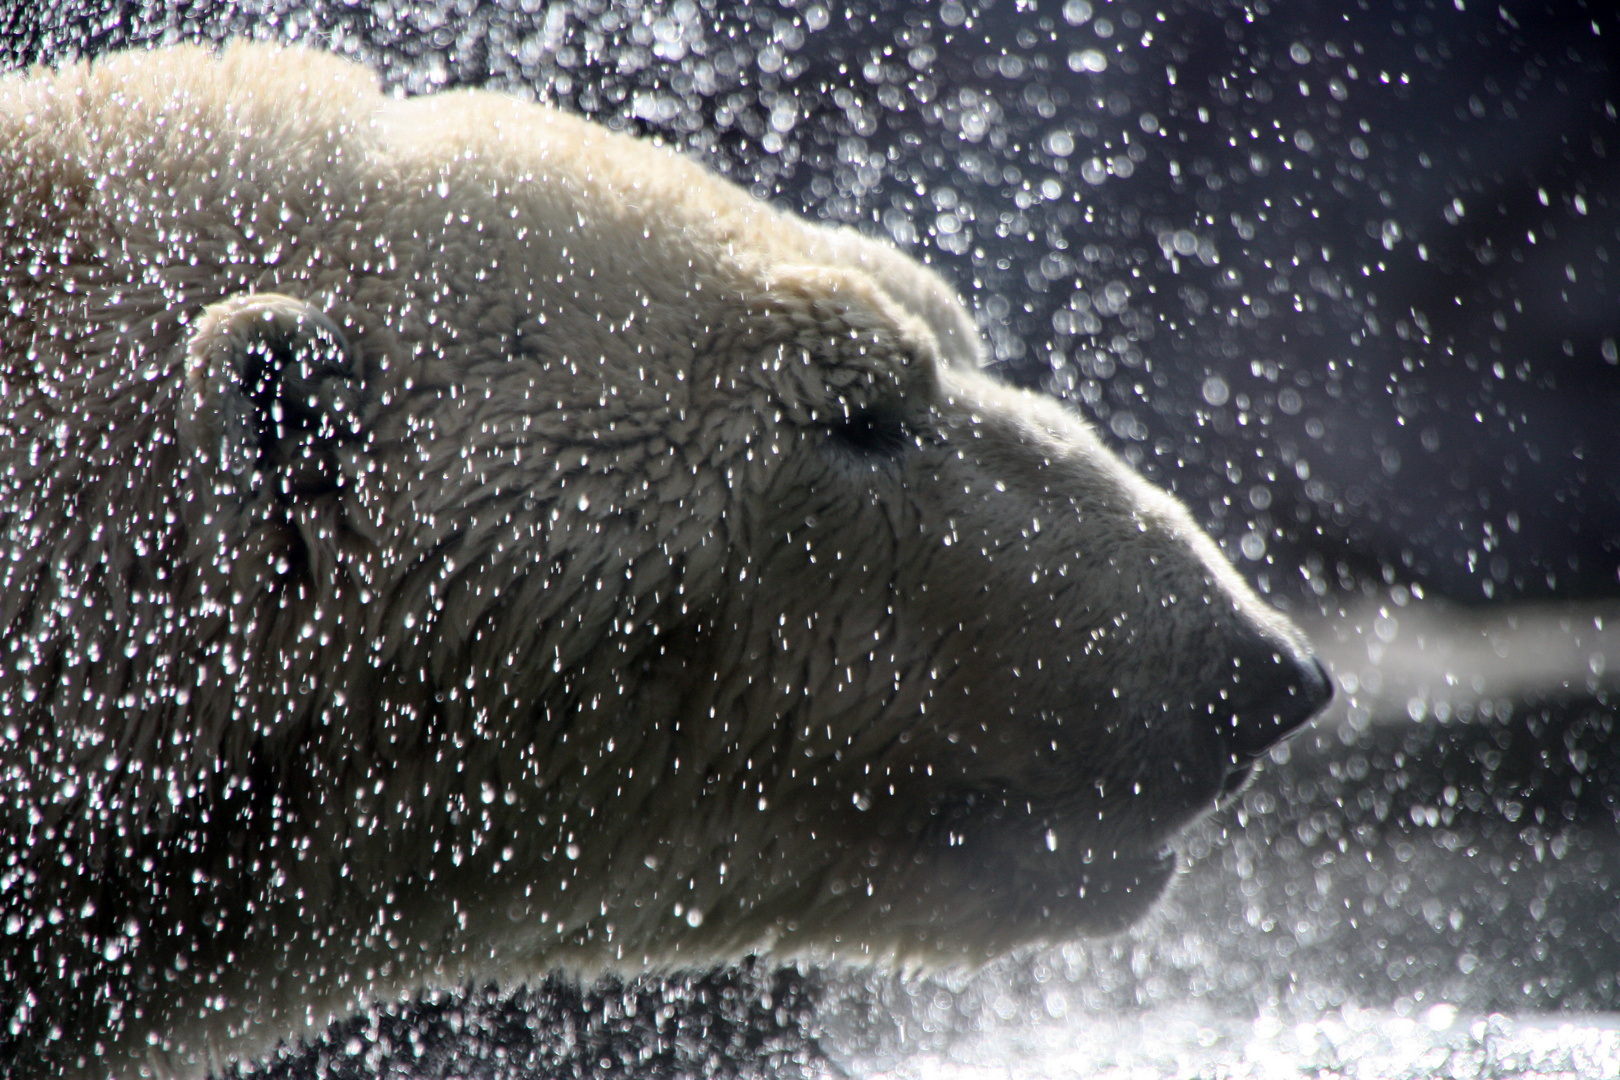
[9,0,1620,1077]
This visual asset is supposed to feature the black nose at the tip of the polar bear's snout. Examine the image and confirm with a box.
[1215,641,1333,764]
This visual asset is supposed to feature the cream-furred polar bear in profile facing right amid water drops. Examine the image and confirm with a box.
[0,45,1328,1077]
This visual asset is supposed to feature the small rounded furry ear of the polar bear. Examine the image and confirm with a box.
[180,293,363,497]
